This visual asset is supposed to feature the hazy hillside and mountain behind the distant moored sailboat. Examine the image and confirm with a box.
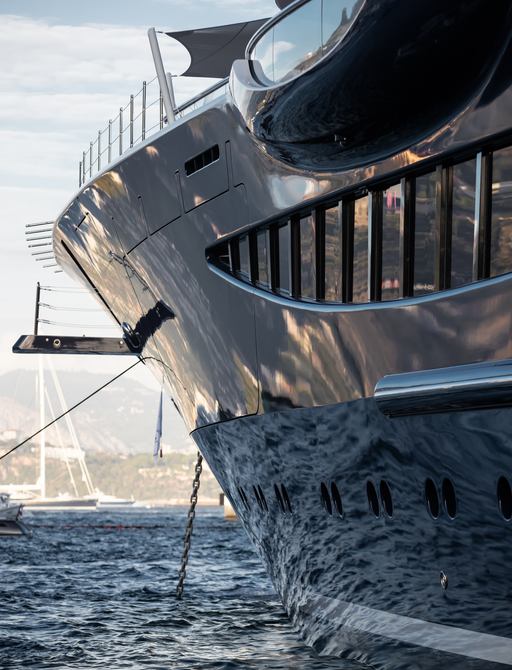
[0,370,220,501]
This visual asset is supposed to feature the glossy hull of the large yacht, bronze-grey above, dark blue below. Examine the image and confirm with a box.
[50,2,512,670]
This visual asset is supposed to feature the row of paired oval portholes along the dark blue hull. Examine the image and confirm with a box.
[237,476,512,521]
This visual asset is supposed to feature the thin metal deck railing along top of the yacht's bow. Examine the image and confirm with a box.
[78,77,228,186]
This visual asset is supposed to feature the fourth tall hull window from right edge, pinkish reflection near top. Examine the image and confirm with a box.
[381,184,402,300]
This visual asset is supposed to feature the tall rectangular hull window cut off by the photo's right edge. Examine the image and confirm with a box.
[491,148,512,277]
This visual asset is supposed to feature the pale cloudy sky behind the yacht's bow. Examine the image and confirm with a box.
[0,0,277,404]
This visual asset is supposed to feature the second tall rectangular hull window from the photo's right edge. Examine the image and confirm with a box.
[450,159,476,288]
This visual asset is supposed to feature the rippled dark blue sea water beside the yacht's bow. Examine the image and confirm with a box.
[0,508,354,670]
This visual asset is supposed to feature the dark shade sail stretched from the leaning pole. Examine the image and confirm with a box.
[166,19,268,79]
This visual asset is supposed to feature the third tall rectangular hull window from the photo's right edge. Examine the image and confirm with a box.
[413,172,439,295]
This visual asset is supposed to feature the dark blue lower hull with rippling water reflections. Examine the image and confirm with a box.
[195,400,512,670]
